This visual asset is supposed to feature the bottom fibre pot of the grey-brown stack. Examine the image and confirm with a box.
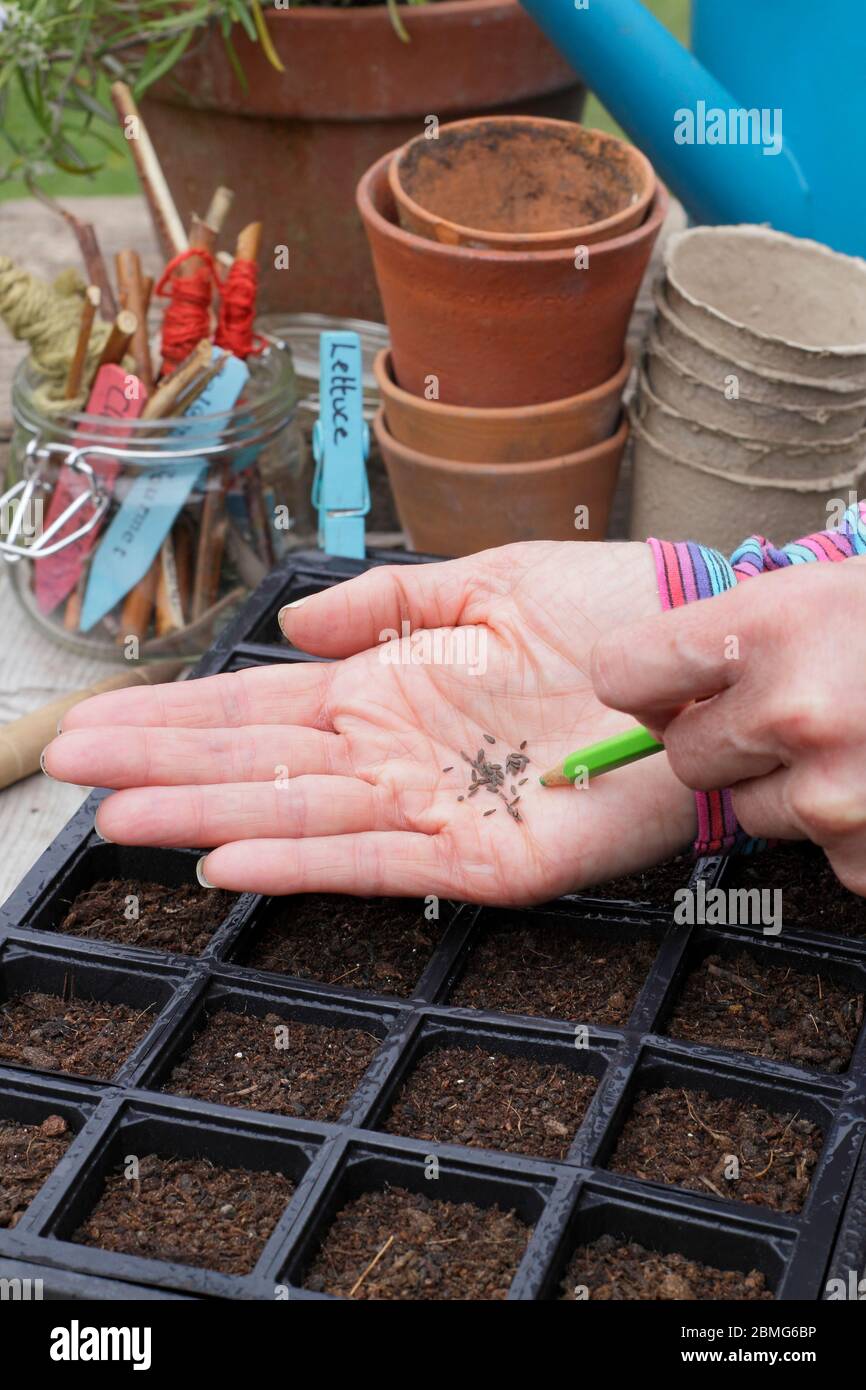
[630,410,866,555]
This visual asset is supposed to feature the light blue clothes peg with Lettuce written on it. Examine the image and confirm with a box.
[313,332,370,560]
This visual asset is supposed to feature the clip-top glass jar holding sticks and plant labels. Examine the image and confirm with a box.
[0,339,306,660]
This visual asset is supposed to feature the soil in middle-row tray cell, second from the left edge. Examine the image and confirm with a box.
[163,1009,379,1120]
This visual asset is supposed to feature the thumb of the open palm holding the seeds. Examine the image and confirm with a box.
[279,556,474,656]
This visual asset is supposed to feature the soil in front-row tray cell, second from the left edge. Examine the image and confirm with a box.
[72,1154,295,1275]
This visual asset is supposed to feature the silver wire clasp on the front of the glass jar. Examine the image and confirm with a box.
[0,435,108,564]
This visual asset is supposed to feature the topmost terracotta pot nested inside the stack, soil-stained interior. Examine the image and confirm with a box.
[388,115,656,252]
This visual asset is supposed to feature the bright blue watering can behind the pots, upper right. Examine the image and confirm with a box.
[521,0,866,256]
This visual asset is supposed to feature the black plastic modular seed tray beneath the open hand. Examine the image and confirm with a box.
[0,553,866,1301]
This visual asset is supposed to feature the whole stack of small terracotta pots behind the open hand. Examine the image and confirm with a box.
[357,117,669,555]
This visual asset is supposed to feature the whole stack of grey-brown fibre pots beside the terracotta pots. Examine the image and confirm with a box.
[631,227,866,549]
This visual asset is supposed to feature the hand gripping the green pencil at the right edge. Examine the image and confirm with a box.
[592,557,866,894]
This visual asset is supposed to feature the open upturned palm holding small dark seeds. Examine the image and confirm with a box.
[44,542,695,904]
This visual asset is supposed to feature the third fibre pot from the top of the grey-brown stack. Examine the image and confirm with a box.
[646,334,866,443]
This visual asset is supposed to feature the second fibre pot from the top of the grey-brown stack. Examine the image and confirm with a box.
[653,284,866,410]
